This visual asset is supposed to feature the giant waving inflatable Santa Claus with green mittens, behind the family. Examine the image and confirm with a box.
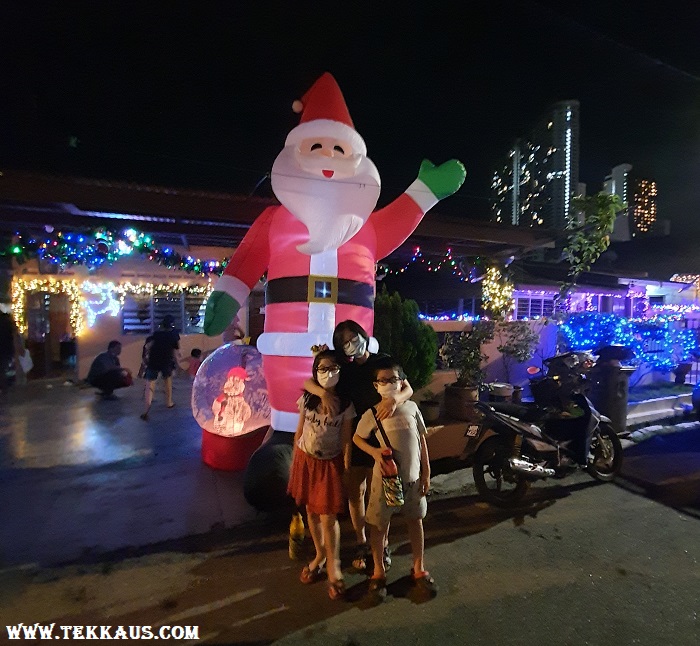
[204,73,466,508]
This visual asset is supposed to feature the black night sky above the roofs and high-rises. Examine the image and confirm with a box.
[0,0,700,233]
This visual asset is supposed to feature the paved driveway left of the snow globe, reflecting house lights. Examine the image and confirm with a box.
[0,380,258,569]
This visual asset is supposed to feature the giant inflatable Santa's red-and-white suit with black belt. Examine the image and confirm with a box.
[216,188,432,432]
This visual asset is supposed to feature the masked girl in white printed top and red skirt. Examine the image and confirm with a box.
[287,349,355,599]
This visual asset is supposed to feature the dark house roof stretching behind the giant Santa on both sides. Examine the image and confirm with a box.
[0,170,553,258]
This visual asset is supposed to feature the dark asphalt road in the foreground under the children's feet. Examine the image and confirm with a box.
[0,432,700,646]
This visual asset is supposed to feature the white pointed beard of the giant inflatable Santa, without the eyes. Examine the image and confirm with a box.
[272,146,380,255]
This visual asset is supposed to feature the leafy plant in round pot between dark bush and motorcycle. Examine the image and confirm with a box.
[440,321,495,420]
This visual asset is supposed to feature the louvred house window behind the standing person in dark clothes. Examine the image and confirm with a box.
[122,291,206,335]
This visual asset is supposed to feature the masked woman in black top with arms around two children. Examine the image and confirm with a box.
[304,321,413,570]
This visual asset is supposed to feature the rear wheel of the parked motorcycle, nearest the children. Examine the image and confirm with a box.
[473,437,529,507]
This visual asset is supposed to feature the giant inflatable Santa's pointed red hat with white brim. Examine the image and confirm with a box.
[285,72,367,155]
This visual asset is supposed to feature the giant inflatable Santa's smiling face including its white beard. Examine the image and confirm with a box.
[272,137,380,254]
